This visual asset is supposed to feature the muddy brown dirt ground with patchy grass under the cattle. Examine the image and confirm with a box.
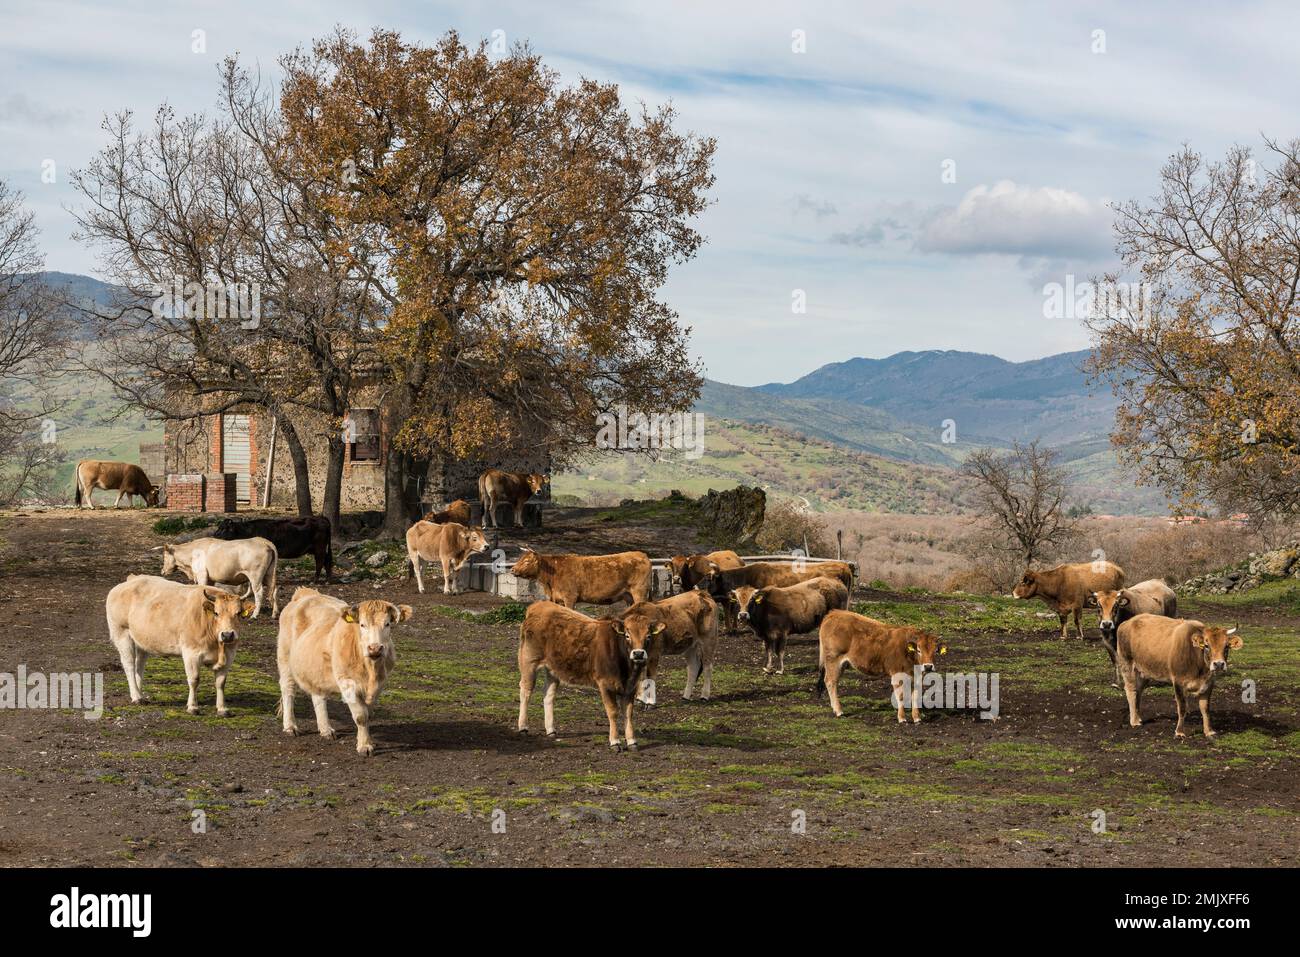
[0,510,1300,866]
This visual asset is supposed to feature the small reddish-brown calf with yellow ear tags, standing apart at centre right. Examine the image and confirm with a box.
[816,610,948,724]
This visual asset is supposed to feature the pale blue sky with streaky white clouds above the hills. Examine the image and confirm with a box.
[0,0,1300,385]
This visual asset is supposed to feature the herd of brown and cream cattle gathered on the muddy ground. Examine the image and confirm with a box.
[78,463,1242,754]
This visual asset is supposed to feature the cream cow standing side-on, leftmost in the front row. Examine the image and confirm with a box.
[104,575,252,718]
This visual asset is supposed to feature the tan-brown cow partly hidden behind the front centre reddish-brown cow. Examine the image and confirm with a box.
[619,589,718,705]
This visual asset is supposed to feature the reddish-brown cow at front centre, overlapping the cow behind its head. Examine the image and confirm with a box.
[517,602,647,752]
